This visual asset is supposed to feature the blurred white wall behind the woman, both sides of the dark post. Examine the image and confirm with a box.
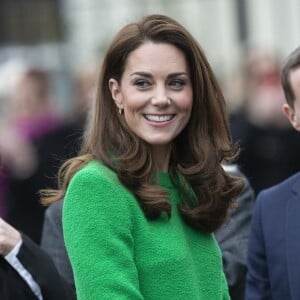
[64,0,300,76]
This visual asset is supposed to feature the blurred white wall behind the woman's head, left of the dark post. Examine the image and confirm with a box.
[64,0,239,78]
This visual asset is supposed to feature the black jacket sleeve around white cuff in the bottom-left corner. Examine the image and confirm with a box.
[0,235,76,300]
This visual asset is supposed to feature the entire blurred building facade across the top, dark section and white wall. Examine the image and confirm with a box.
[0,0,300,114]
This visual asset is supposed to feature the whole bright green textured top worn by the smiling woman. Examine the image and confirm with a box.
[63,162,229,300]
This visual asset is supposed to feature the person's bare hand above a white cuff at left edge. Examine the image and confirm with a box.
[0,218,22,256]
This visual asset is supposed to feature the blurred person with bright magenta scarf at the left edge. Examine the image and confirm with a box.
[0,67,61,242]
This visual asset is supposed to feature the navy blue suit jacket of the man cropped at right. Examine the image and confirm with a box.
[246,173,300,300]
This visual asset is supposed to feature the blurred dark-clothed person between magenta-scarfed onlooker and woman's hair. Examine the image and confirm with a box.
[34,63,97,189]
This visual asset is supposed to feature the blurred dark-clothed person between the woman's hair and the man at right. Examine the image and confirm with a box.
[226,49,300,194]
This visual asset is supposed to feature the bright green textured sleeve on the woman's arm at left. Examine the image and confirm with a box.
[63,169,143,300]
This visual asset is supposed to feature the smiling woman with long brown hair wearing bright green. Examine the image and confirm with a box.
[44,15,243,300]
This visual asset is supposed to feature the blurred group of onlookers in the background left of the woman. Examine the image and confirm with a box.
[0,60,96,243]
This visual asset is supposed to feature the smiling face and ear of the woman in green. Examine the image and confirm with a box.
[109,42,193,147]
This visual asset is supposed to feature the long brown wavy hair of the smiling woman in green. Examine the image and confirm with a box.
[42,15,243,232]
